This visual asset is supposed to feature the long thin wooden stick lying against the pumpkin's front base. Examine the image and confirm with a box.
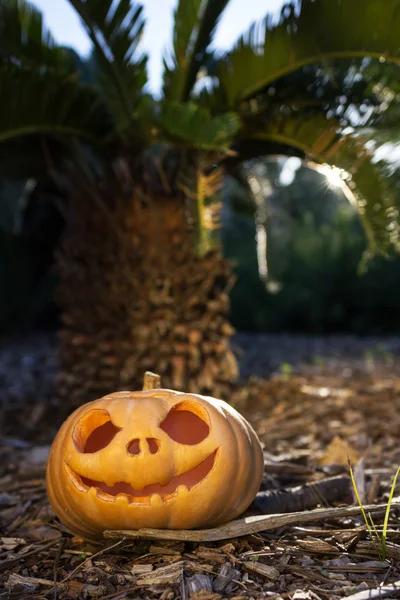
[103,503,400,542]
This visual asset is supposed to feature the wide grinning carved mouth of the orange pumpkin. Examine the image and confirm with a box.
[65,449,218,504]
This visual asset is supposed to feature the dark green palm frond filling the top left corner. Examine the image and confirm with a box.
[0,0,74,71]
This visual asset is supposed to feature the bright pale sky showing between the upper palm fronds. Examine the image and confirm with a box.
[33,0,283,93]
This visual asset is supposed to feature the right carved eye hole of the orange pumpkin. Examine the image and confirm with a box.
[160,401,210,446]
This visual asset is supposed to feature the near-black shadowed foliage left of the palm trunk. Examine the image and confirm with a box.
[0,182,64,332]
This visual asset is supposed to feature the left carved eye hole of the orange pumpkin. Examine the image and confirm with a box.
[72,409,121,454]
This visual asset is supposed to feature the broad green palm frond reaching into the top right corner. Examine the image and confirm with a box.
[218,0,400,108]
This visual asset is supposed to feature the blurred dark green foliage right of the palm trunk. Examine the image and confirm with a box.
[223,165,400,335]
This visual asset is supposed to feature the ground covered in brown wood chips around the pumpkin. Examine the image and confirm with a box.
[0,334,400,600]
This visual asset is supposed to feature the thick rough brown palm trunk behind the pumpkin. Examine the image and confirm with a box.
[57,192,237,407]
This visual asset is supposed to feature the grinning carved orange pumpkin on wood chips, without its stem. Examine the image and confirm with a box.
[46,389,263,539]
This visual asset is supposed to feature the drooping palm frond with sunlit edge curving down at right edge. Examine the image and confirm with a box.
[237,110,400,255]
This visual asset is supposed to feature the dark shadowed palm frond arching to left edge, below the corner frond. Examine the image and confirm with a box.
[0,63,114,143]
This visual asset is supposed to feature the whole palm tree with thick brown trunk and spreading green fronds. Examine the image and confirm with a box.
[0,0,400,405]
